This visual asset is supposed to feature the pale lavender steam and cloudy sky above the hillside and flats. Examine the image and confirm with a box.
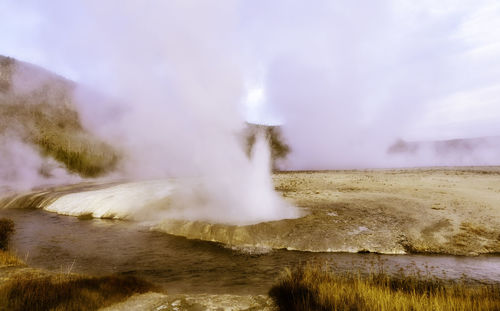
[0,0,500,178]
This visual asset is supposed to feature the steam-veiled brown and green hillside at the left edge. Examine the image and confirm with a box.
[0,56,119,177]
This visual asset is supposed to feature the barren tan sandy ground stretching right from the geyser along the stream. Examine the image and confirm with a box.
[156,167,500,255]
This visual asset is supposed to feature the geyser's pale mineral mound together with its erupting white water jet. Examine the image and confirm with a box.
[42,136,300,225]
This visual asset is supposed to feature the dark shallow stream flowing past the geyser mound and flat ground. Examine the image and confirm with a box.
[0,209,500,294]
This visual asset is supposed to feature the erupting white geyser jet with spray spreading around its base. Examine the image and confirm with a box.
[163,134,300,225]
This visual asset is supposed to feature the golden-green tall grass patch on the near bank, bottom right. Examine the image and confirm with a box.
[269,264,500,311]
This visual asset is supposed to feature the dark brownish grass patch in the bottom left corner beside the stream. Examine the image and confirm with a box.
[0,274,156,311]
